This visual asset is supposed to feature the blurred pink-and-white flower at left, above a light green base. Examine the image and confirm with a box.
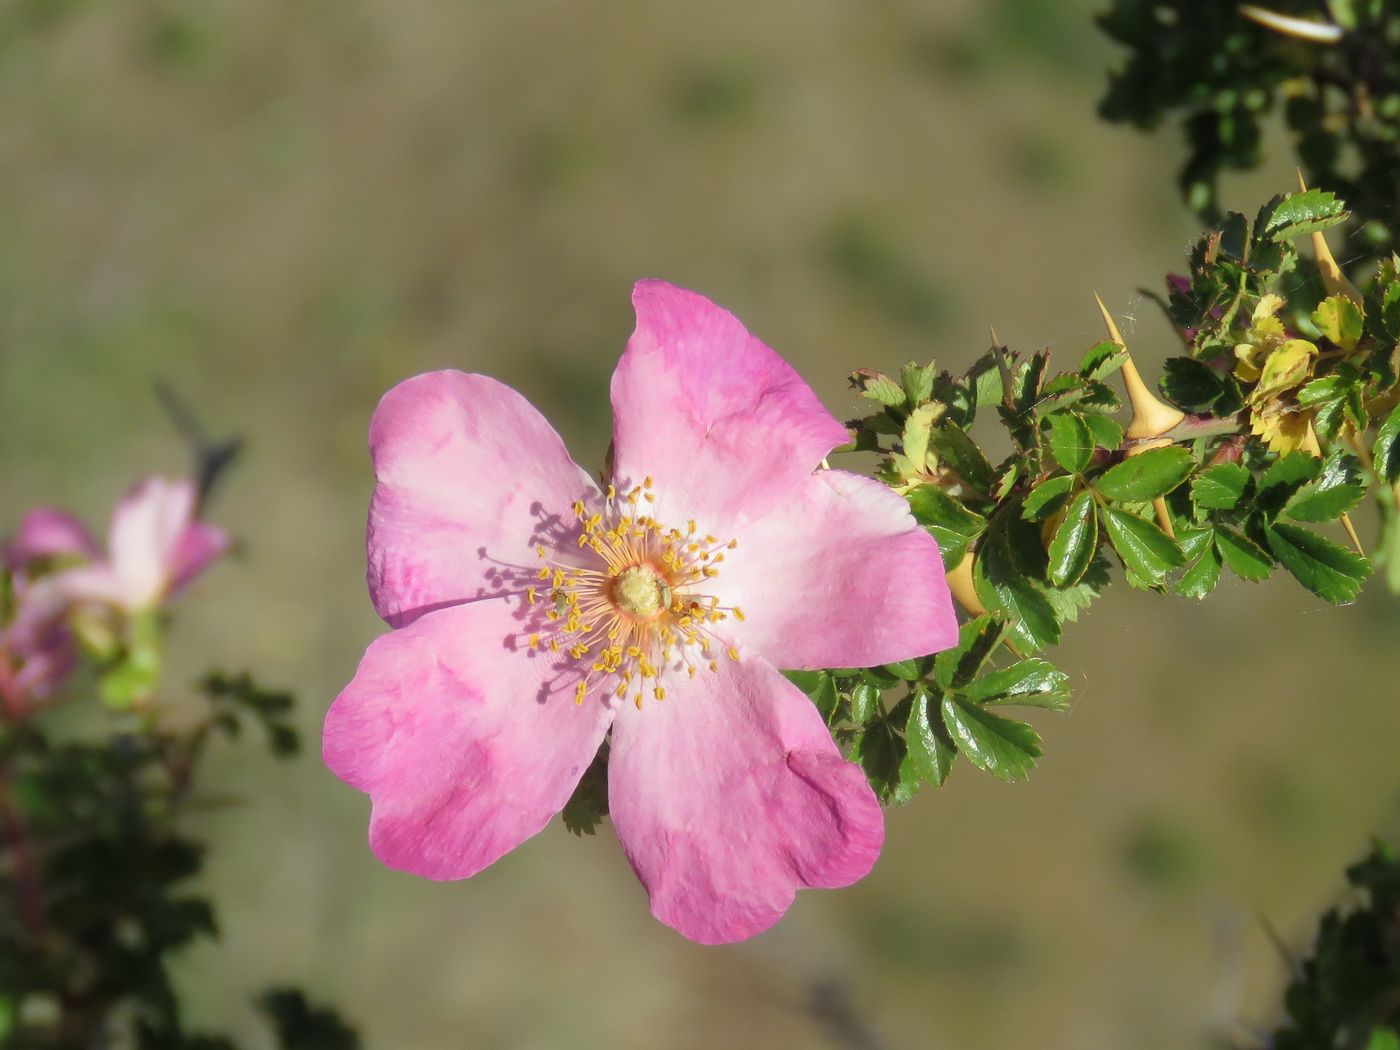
[56,477,228,612]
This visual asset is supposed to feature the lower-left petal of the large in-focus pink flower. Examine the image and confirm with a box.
[322,599,612,879]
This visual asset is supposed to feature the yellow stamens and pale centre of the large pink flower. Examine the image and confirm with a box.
[525,477,743,707]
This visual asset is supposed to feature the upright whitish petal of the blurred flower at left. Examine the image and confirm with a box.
[108,477,196,609]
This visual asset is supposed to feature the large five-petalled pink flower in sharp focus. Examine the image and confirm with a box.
[323,281,956,944]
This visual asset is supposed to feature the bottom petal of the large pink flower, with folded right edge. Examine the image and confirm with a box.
[608,655,885,944]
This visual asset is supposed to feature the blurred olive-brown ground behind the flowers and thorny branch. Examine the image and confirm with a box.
[0,0,1400,1050]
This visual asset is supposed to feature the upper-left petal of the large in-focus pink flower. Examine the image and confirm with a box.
[368,371,598,627]
